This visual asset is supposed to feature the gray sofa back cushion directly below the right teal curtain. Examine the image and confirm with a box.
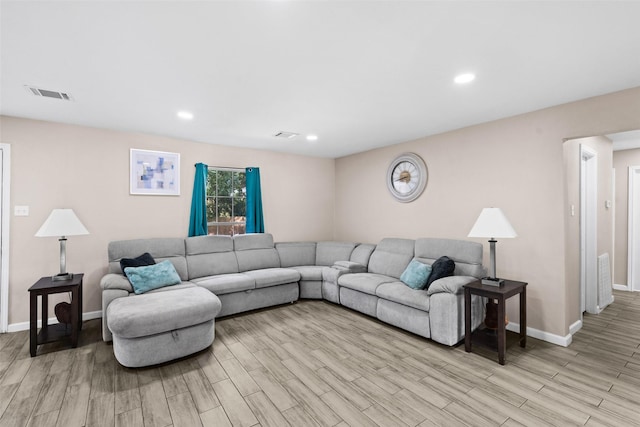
[233,233,280,272]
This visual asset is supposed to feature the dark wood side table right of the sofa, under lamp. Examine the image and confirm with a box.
[464,280,527,365]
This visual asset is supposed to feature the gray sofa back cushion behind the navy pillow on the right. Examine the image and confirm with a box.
[415,238,485,278]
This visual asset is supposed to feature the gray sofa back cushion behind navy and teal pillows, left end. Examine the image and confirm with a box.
[107,238,189,280]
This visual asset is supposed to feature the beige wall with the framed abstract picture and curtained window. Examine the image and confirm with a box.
[0,117,335,324]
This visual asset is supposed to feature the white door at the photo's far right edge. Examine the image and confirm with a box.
[627,166,640,291]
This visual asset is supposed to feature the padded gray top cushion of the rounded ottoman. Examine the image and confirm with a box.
[107,287,222,338]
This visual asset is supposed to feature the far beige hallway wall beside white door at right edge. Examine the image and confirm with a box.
[613,149,640,286]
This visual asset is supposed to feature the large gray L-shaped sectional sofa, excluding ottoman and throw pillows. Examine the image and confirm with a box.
[101,234,485,366]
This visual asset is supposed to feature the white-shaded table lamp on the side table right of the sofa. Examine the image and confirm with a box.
[467,208,518,286]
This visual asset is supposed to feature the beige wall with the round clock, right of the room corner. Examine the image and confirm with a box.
[336,88,640,342]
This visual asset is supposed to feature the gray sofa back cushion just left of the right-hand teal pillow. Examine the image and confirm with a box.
[369,238,415,279]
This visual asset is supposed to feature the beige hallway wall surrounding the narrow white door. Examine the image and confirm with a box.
[563,136,613,320]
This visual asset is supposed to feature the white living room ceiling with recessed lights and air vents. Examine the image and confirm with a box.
[0,0,640,157]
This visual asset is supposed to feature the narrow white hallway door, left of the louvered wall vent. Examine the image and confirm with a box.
[580,144,598,314]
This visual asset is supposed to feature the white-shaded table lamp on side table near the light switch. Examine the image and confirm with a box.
[36,209,89,281]
